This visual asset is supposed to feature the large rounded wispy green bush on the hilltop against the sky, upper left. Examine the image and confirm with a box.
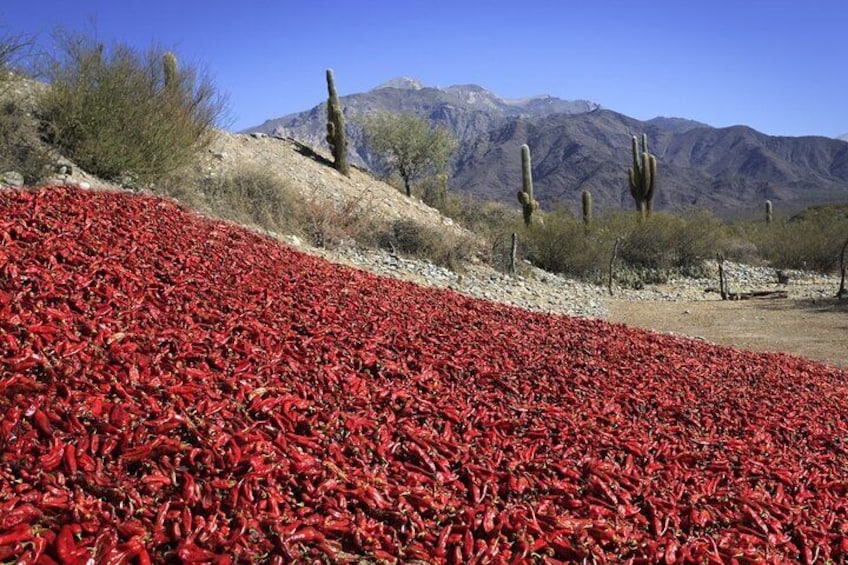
[40,32,226,184]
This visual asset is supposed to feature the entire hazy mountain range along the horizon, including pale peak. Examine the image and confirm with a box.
[247,78,848,214]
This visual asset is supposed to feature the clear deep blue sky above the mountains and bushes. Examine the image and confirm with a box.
[0,0,848,137]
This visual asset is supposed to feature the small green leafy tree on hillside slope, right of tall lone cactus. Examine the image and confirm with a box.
[362,112,457,196]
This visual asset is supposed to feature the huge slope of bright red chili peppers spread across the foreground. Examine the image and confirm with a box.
[0,187,848,564]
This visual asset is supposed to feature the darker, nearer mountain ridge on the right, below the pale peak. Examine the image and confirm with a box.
[452,110,848,212]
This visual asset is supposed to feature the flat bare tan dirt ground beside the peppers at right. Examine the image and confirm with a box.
[606,299,848,368]
